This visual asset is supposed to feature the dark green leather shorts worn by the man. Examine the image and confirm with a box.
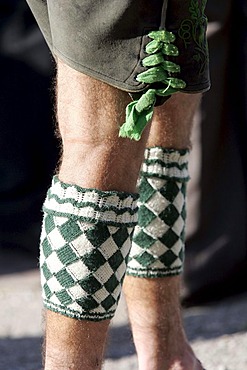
[27,0,210,93]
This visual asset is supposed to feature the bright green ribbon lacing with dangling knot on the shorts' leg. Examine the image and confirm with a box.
[119,30,186,140]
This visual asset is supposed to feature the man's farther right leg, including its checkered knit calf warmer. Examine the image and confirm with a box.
[124,94,202,370]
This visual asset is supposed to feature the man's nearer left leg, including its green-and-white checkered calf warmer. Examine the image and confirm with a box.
[41,61,148,370]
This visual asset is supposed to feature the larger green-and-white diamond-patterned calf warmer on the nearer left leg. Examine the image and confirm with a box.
[40,177,137,321]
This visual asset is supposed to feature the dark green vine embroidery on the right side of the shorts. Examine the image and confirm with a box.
[178,0,208,74]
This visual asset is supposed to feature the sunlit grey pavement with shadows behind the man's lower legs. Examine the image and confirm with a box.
[0,252,247,370]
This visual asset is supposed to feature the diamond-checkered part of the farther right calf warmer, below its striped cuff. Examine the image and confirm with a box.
[127,177,186,278]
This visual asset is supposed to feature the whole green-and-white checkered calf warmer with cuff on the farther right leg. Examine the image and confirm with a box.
[127,147,189,278]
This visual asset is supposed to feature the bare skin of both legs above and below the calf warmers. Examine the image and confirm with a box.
[44,60,202,370]
